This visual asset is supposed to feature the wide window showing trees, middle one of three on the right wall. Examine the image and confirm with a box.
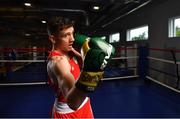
[127,26,148,41]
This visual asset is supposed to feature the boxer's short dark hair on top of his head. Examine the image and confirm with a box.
[47,16,74,35]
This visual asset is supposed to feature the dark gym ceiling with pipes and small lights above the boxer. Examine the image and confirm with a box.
[0,0,165,37]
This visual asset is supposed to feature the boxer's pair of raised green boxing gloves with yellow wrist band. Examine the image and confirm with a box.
[75,34,115,92]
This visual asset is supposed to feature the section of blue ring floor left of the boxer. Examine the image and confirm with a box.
[0,85,54,118]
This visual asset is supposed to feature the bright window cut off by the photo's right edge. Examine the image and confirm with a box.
[169,17,180,37]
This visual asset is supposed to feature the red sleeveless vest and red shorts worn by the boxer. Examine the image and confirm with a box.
[48,52,94,119]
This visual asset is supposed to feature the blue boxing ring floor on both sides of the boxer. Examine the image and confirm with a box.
[0,79,180,118]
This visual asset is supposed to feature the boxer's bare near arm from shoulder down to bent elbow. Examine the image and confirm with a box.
[49,55,86,110]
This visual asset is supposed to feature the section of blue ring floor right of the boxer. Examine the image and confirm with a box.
[91,80,180,118]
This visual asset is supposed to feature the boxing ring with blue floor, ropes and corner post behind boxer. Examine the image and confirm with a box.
[0,45,180,118]
